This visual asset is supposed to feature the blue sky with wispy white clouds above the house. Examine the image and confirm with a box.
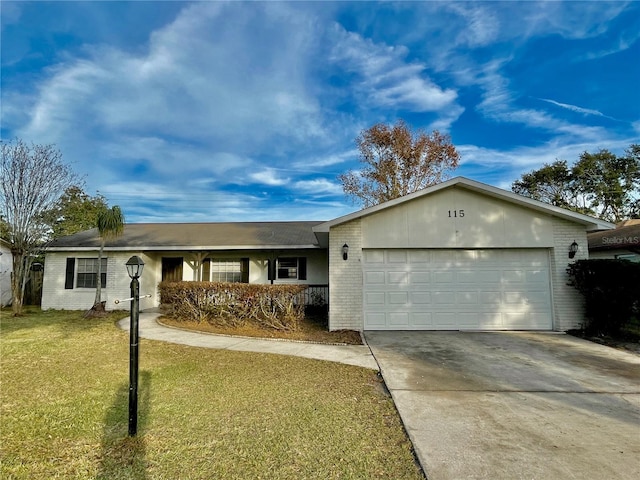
[0,0,640,222]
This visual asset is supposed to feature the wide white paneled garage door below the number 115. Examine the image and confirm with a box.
[362,249,552,330]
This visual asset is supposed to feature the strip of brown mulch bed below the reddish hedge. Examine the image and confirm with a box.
[158,316,362,345]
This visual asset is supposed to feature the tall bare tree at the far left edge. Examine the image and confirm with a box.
[0,139,77,315]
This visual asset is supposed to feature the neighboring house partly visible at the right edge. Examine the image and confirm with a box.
[588,219,640,262]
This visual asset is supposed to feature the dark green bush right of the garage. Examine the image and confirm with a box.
[567,259,640,335]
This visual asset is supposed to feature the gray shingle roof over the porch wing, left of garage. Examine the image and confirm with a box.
[50,222,322,250]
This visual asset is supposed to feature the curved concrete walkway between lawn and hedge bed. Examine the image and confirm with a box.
[118,312,378,370]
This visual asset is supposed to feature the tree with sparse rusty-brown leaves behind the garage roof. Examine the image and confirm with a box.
[338,120,460,207]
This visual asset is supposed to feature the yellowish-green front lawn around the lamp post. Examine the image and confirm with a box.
[0,310,423,480]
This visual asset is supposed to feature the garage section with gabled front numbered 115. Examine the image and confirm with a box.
[314,177,613,331]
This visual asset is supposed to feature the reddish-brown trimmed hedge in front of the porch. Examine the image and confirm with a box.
[159,282,306,331]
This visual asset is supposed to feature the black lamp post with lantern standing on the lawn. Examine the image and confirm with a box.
[126,255,144,437]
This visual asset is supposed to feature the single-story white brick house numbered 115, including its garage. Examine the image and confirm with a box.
[42,177,614,331]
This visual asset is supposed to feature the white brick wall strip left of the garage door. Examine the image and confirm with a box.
[329,219,364,330]
